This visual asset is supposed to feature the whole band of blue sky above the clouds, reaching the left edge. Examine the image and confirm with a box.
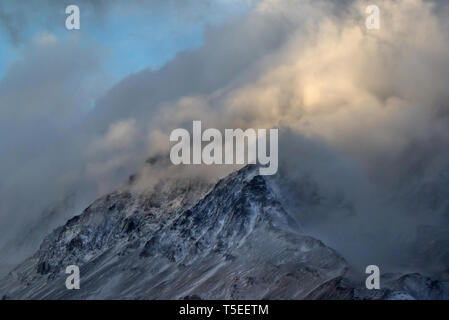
[0,0,252,80]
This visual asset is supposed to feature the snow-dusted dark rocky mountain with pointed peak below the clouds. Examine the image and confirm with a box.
[0,166,449,299]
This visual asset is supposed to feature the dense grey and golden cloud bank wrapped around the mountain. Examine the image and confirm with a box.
[0,0,449,276]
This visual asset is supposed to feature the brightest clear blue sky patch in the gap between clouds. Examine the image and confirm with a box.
[84,1,249,78]
